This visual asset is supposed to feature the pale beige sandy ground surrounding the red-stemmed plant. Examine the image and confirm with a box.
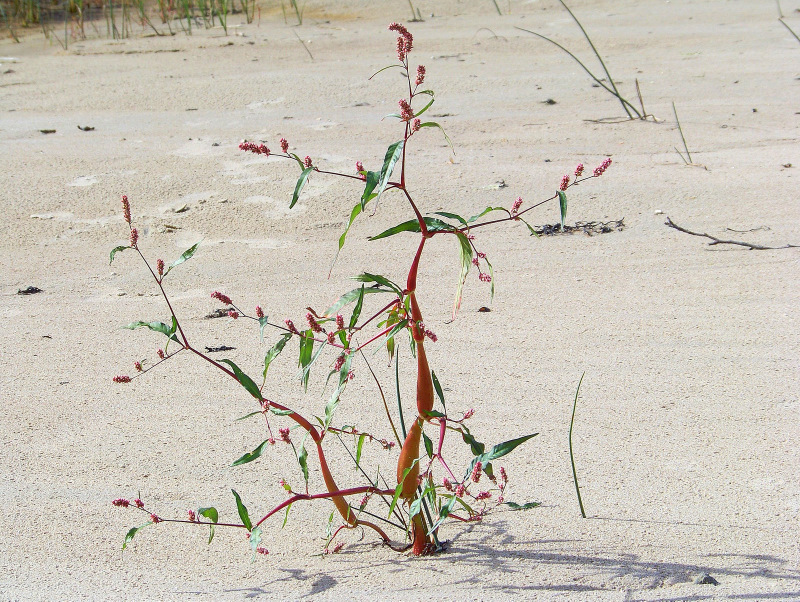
[0,0,800,601]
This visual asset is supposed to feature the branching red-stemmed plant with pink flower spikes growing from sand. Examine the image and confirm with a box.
[111,23,611,556]
